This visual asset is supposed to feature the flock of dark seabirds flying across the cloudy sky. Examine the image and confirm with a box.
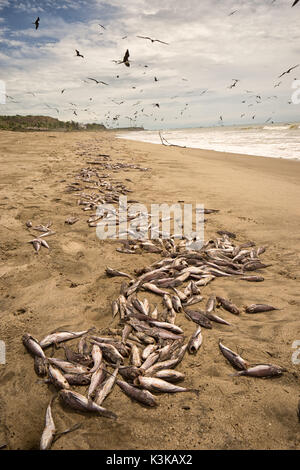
[6,0,300,127]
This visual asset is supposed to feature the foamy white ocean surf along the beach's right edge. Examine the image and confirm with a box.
[118,124,300,160]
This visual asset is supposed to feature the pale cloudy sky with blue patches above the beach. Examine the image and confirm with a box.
[0,0,300,129]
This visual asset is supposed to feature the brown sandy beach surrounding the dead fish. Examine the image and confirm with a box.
[0,132,300,449]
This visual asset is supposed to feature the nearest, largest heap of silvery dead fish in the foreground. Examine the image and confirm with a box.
[23,234,284,449]
